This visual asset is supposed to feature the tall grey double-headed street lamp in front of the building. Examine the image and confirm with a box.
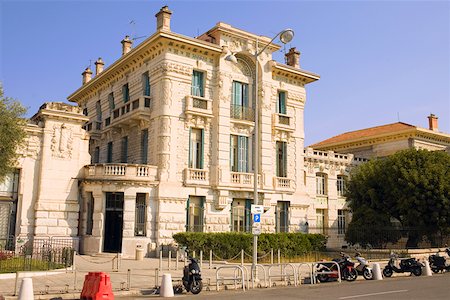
[225,28,294,277]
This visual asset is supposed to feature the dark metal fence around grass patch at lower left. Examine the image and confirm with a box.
[0,237,79,273]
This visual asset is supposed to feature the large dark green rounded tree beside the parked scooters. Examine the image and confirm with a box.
[346,149,450,247]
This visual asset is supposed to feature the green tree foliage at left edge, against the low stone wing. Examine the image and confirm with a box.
[0,82,27,182]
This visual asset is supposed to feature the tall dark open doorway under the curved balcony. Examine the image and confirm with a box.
[103,193,123,253]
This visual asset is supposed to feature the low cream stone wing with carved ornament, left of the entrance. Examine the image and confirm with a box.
[0,103,90,247]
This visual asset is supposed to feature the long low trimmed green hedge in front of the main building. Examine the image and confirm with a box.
[173,232,327,258]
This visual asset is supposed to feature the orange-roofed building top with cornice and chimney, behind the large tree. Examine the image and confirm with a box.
[311,114,450,158]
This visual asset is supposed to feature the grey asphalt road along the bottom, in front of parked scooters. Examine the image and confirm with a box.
[115,273,450,300]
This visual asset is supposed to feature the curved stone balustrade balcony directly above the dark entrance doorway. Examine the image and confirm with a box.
[84,164,158,182]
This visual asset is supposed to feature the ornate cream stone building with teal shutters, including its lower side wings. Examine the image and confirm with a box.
[0,7,372,256]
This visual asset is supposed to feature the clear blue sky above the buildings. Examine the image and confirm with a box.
[0,0,450,145]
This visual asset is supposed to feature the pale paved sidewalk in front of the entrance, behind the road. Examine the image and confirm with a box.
[0,254,400,300]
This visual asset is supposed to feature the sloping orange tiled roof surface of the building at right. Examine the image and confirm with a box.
[311,122,417,149]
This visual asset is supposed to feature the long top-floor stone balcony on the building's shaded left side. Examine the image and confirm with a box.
[105,96,151,127]
